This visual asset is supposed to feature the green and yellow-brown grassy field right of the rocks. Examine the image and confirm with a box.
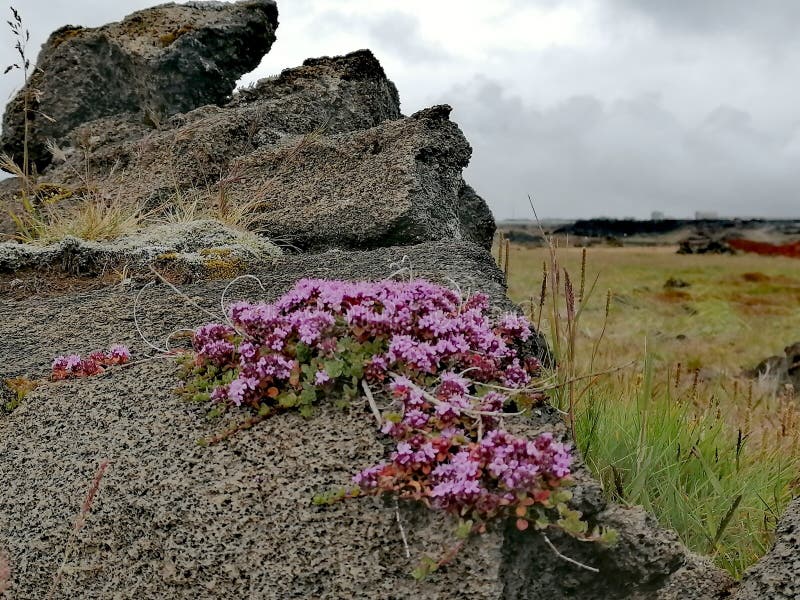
[508,246,800,577]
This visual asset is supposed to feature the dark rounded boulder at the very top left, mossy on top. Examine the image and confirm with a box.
[0,0,278,171]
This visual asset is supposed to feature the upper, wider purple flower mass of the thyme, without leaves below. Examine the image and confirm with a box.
[194,279,530,410]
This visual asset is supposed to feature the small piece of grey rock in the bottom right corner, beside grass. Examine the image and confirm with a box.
[733,498,800,600]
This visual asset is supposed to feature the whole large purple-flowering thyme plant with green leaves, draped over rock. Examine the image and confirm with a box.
[181,279,613,577]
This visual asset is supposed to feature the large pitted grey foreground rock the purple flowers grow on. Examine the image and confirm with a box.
[0,242,729,600]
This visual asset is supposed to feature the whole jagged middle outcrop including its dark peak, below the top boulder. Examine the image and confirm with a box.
[0,51,495,251]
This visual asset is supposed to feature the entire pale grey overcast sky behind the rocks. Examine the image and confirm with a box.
[0,0,800,218]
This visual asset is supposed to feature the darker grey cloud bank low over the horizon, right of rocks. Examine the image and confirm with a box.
[445,79,800,217]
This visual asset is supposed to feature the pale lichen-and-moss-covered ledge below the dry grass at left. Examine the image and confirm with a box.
[0,221,281,279]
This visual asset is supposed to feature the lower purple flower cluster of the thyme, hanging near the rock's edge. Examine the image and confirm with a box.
[353,372,572,517]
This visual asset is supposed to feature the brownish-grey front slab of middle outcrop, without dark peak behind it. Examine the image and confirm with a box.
[42,102,494,251]
